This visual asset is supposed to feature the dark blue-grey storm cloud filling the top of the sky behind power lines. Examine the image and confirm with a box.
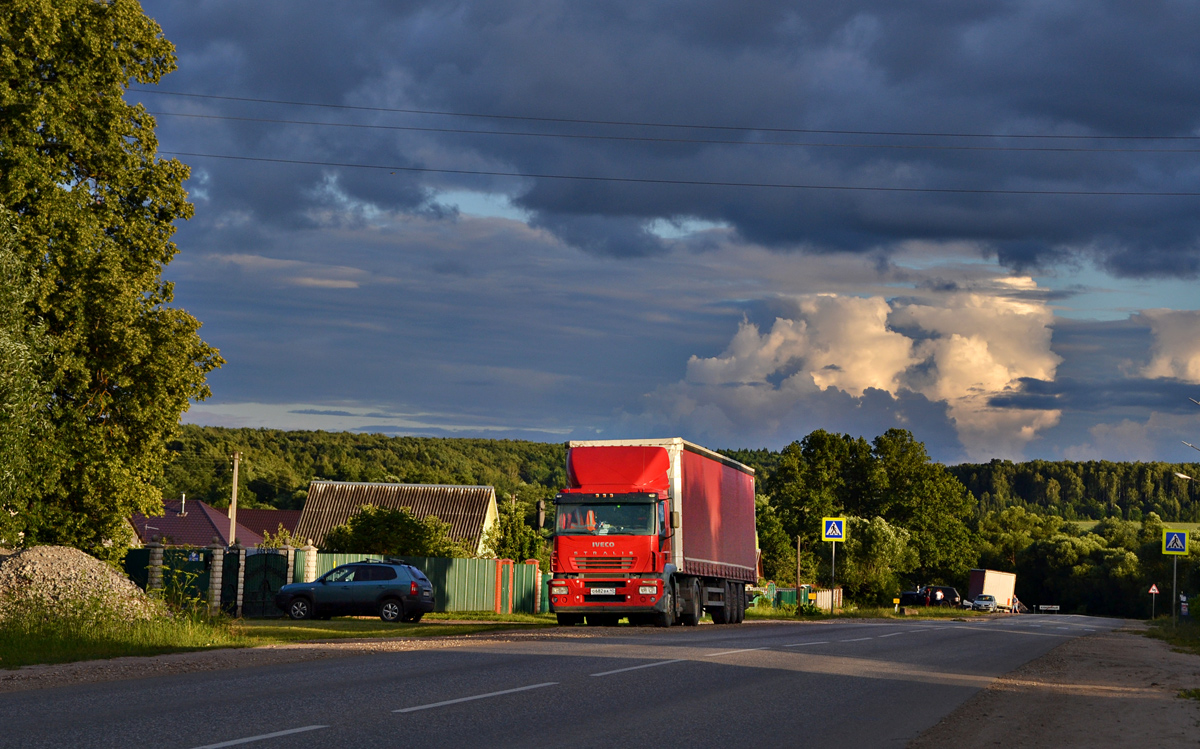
[139,0,1200,276]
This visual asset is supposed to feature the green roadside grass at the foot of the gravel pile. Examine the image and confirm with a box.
[0,601,251,669]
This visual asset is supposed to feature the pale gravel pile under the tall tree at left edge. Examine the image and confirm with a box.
[0,546,158,619]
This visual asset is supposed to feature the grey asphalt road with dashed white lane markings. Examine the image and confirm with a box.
[0,616,1120,749]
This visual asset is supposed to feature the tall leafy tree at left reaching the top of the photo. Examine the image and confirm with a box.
[0,0,221,558]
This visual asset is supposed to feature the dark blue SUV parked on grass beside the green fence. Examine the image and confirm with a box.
[275,562,433,622]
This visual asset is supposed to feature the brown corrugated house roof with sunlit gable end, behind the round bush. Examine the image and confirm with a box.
[296,481,496,553]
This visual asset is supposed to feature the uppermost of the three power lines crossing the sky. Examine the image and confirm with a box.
[130,88,1200,140]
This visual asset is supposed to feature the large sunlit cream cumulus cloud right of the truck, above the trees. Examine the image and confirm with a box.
[658,278,1061,460]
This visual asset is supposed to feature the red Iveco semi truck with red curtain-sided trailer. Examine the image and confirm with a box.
[550,437,758,627]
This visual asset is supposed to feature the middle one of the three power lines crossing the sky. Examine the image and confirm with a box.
[149,112,1200,154]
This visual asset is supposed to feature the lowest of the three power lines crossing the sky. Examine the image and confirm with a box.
[160,151,1200,198]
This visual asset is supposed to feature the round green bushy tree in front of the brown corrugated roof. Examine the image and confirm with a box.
[323,504,472,557]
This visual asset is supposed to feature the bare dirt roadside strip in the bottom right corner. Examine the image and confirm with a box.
[908,625,1200,749]
